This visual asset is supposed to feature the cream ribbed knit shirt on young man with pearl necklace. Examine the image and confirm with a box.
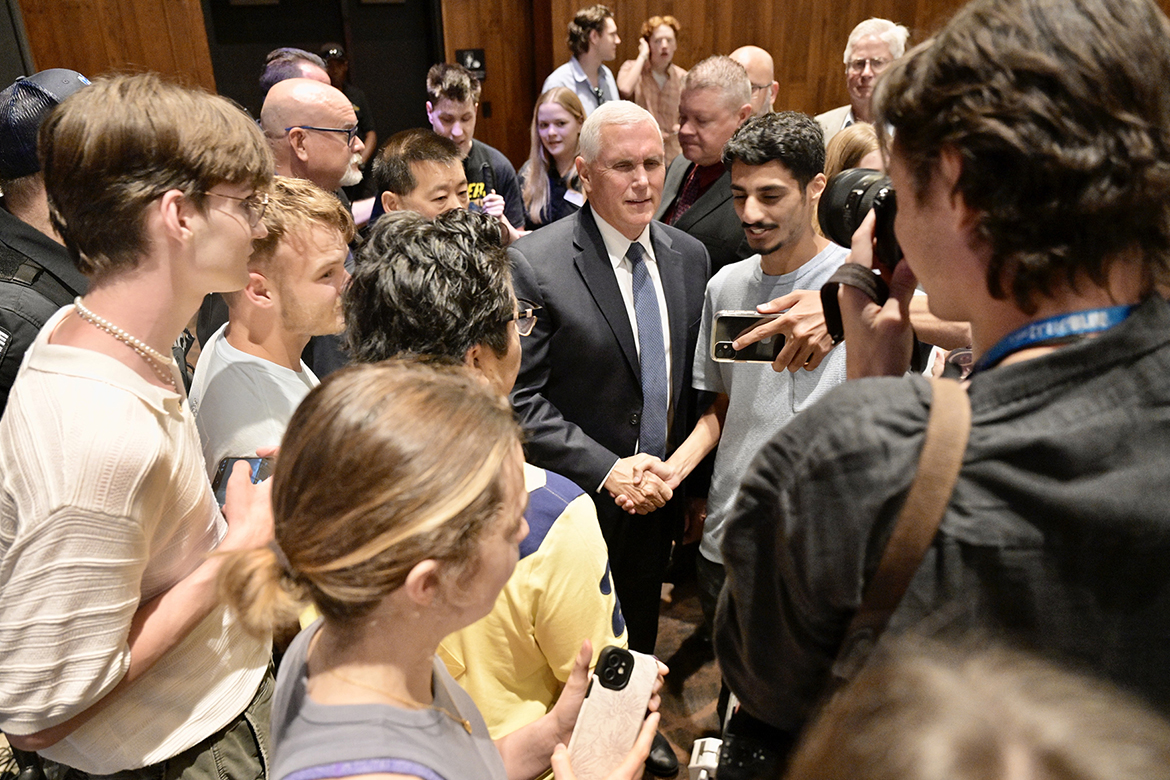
[0,306,270,774]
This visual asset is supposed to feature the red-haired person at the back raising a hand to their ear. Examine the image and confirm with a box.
[618,16,687,165]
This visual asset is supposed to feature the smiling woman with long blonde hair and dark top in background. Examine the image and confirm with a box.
[519,87,585,230]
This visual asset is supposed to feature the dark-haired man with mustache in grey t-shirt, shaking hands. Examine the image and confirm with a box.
[636,111,848,645]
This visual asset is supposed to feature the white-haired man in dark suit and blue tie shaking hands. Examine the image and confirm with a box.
[508,101,709,653]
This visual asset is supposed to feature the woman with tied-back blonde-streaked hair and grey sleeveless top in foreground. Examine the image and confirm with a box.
[220,362,658,780]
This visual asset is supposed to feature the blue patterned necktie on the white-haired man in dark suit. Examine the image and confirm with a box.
[626,241,670,457]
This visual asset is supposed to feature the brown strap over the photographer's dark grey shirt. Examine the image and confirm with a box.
[833,379,971,679]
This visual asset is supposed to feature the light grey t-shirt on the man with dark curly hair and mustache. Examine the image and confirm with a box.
[693,243,849,564]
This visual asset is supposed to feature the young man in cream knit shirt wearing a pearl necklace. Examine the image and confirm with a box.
[0,75,273,780]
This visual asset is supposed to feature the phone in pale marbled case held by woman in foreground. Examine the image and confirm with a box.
[569,646,658,780]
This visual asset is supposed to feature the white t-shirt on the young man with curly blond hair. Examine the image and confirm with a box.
[191,325,321,477]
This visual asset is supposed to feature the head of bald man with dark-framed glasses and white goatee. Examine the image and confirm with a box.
[260,78,365,192]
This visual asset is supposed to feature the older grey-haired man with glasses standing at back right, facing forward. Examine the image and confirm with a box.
[817,18,910,145]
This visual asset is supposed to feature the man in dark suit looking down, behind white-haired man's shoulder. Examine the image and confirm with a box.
[654,56,753,274]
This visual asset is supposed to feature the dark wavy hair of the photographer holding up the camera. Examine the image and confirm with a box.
[874,0,1170,313]
